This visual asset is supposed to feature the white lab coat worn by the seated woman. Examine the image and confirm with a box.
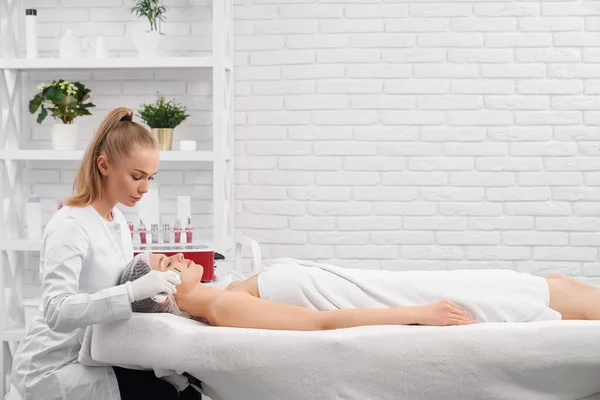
[11,206,133,400]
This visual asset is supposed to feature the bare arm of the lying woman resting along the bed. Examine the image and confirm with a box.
[206,292,475,331]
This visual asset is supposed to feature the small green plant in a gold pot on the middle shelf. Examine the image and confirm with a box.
[138,93,189,150]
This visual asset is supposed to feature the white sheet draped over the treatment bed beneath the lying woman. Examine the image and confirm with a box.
[80,314,600,400]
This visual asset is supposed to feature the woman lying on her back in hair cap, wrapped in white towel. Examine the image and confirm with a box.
[120,254,600,330]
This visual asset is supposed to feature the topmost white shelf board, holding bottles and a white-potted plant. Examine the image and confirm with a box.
[0,57,221,71]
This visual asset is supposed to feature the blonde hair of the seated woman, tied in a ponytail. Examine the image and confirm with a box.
[63,107,158,207]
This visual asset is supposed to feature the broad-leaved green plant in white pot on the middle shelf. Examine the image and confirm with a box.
[29,79,95,150]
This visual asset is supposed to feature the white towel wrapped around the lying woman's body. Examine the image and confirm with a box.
[258,258,561,322]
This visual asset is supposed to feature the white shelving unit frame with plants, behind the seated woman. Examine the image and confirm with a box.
[0,0,235,396]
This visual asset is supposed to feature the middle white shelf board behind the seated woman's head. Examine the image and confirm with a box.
[0,150,213,162]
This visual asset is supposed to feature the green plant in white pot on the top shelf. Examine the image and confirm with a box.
[130,0,167,57]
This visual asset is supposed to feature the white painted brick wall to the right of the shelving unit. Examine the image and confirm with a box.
[235,0,600,279]
